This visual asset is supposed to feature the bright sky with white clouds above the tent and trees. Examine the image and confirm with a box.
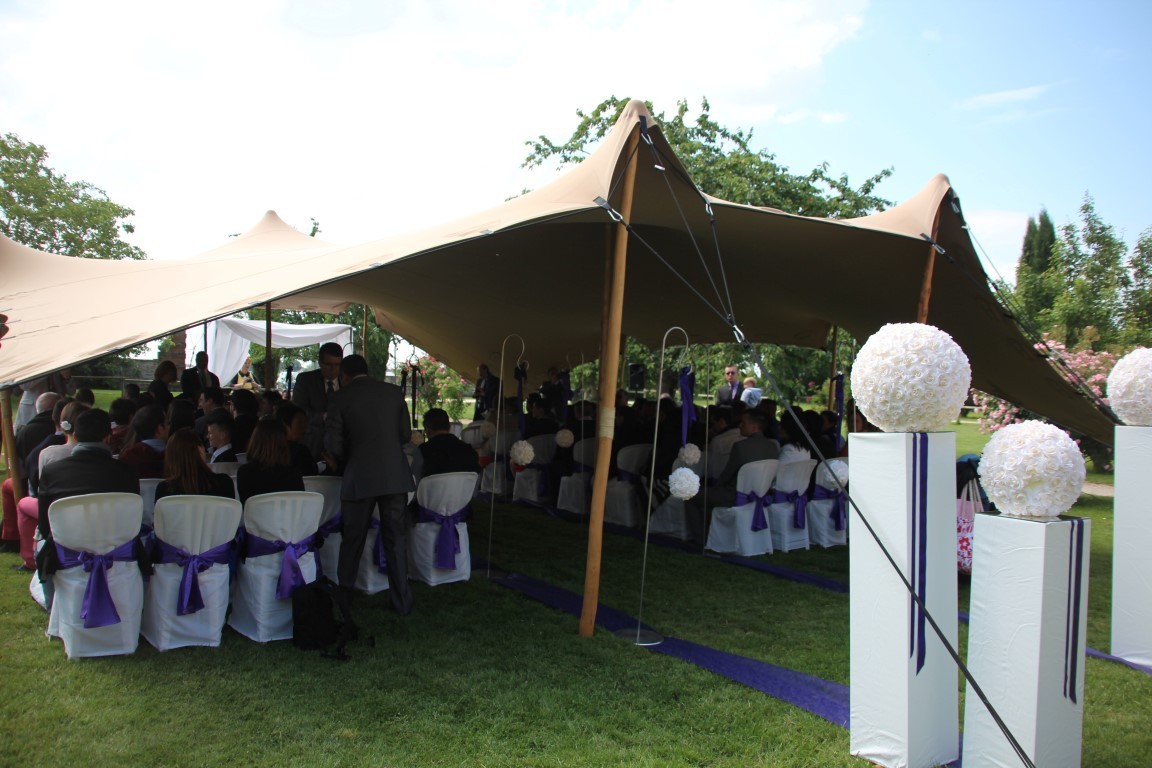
[0,0,1152,277]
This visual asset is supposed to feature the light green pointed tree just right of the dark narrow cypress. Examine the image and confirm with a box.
[1045,195,1129,347]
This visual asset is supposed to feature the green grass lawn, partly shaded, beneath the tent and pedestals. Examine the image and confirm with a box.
[0,483,1152,768]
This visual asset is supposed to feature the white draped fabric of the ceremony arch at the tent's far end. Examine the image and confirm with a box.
[188,318,353,387]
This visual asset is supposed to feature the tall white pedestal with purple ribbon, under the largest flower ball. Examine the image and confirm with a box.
[849,432,960,768]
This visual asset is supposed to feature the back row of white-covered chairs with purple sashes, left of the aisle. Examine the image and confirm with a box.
[33,472,476,659]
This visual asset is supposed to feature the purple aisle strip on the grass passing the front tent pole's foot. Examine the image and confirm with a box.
[498,573,849,728]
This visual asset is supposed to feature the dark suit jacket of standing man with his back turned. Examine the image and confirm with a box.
[324,377,416,500]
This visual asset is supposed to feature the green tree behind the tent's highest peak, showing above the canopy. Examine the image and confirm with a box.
[524,97,892,218]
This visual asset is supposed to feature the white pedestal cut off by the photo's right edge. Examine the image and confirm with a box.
[1112,427,1152,666]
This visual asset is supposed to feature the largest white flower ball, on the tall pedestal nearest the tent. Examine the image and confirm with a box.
[852,322,972,432]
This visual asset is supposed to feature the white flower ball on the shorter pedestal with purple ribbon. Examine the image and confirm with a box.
[979,421,1084,517]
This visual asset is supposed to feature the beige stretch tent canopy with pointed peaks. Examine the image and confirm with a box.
[0,101,1113,442]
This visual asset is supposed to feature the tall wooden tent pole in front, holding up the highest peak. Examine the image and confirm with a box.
[579,127,639,637]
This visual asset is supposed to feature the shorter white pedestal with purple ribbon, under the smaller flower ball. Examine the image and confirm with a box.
[964,515,1091,768]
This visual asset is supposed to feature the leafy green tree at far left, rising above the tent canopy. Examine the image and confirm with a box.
[0,134,147,259]
